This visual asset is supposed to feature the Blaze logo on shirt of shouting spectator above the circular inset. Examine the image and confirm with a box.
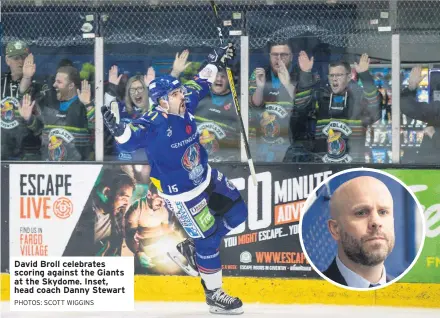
[322,121,353,162]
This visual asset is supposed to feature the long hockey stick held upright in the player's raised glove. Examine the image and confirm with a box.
[210,1,258,186]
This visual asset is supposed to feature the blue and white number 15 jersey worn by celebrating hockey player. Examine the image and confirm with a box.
[117,78,211,201]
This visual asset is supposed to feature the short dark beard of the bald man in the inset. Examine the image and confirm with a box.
[341,231,392,266]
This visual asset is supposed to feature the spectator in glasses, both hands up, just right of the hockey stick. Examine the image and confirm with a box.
[249,42,317,162]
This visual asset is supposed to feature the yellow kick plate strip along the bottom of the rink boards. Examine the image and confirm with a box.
[1,274,440,308]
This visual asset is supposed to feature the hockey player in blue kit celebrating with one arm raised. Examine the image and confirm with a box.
[102,44,248,314]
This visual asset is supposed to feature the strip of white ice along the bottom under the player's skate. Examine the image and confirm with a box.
[1,302,440,318]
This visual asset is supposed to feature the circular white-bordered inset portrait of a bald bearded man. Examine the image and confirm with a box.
[300,168,426,291]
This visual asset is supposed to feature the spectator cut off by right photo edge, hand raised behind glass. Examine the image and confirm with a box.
[400,66,440,164]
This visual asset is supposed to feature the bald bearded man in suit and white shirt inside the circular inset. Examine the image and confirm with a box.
[323,176,395,288]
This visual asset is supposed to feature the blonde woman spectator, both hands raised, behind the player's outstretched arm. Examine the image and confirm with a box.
[104,65,155,163]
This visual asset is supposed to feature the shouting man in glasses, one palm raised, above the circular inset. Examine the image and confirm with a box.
[314,54,382,163]
